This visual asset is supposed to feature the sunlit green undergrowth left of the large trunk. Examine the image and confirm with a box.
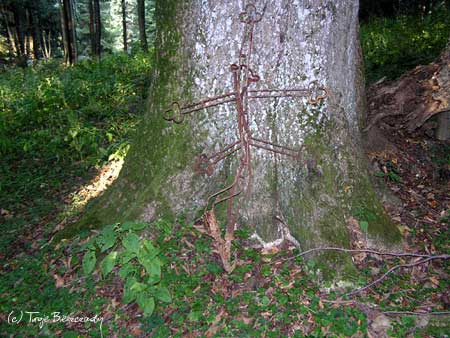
[0,54,152,254]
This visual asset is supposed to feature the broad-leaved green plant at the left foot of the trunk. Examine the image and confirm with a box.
[83,222,172,316]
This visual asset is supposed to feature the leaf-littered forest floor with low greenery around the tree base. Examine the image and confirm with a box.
[0,103,450,337]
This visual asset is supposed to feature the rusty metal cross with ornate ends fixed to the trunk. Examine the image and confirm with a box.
[164,4,327,231]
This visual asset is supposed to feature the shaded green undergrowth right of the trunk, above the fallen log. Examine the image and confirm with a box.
[361,6,450,83]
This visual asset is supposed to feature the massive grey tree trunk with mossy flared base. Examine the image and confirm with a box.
[74,0,399,278]
